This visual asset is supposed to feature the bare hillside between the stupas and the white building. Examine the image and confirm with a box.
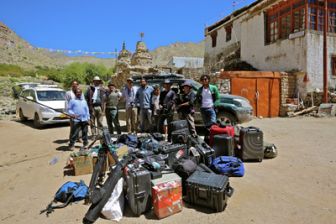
[151,41,204,65]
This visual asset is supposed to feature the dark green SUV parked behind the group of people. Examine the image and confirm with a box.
[132,73,253,125]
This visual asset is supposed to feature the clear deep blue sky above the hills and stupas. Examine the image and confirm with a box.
[0,0,254,52]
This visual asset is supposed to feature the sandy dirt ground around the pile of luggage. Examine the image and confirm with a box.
[0,117,336,224]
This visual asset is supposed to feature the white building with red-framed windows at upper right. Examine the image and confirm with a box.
[204,0,336,88]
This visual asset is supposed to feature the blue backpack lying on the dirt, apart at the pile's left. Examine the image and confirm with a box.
[40,180,89,216]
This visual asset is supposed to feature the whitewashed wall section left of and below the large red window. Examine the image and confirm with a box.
[241,13,306,71]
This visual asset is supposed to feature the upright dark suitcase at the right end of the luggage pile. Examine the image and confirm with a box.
[237,127,264,162]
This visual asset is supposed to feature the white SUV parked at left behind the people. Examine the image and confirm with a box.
[16,86,69,128]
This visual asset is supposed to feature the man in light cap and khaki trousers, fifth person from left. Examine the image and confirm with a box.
[122,78,138,133]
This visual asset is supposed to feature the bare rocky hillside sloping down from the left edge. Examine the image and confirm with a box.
[0,22,115,69]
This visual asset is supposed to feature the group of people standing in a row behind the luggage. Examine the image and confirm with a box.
[66,75,219,150]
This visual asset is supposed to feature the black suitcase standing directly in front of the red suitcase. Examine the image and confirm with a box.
[212,134,234,157]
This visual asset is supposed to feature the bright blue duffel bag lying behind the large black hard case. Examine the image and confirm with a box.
[210,156,245,177]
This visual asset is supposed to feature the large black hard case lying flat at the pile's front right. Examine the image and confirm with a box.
[186,170,233,212]
